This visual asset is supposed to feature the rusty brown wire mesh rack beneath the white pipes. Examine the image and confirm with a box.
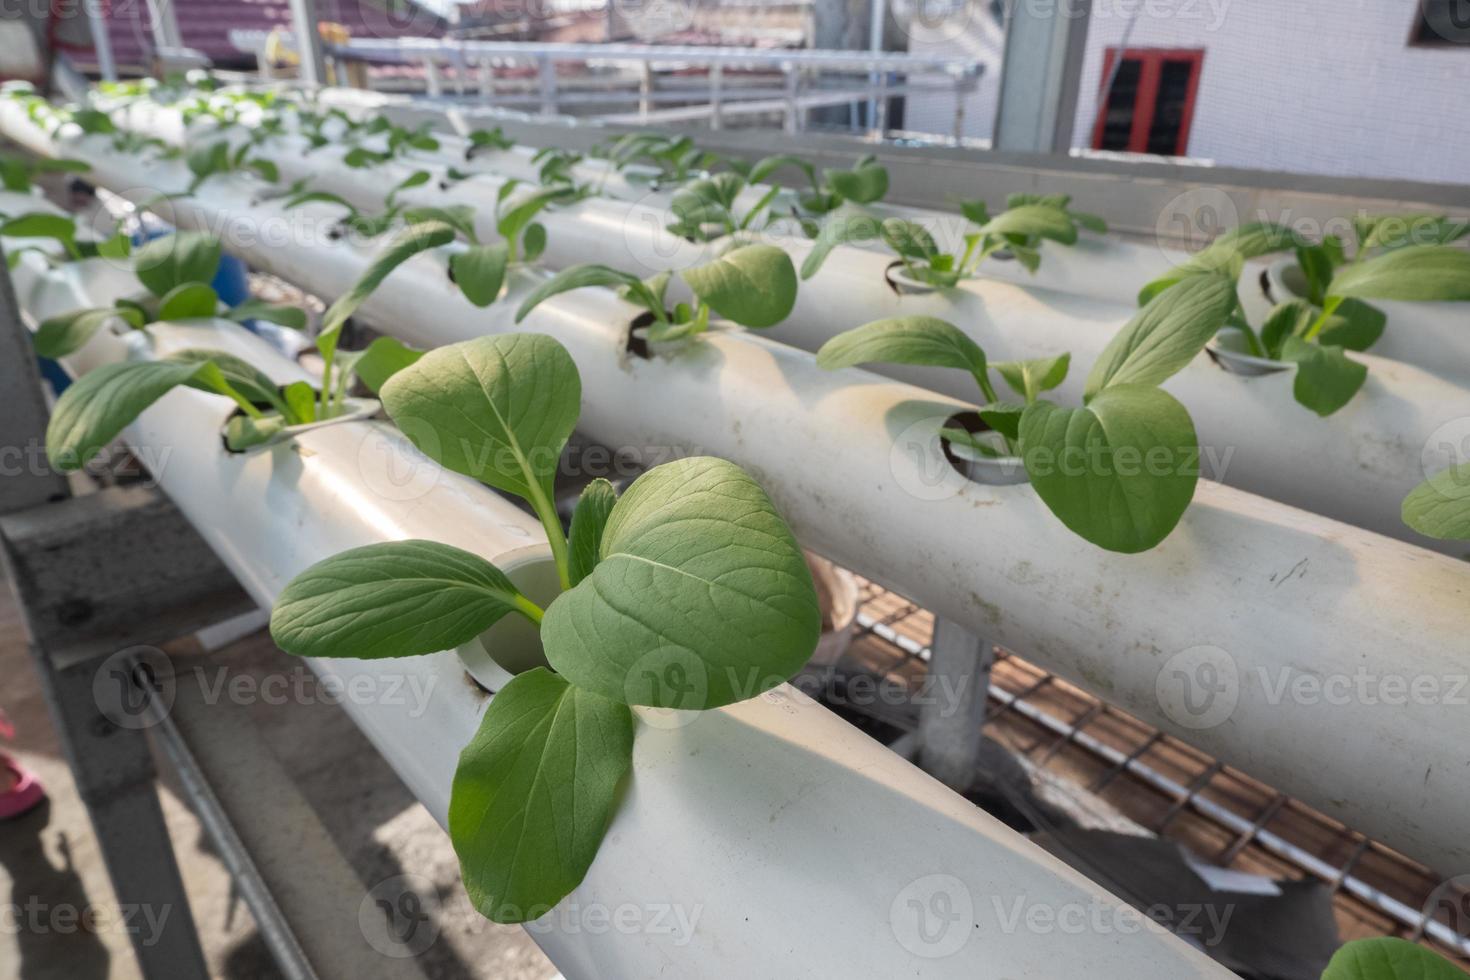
[825,579,1470,968]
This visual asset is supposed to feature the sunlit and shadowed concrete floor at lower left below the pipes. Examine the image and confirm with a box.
[0,579,556,980]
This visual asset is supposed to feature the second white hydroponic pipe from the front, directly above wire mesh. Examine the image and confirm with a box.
[14,134,1470,870]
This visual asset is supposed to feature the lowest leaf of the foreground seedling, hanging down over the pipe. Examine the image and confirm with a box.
[448,667,634,923]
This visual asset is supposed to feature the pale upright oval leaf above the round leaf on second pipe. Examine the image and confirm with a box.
[1083,273,1236,400]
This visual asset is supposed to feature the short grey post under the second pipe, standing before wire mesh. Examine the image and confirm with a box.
[919,619,995,793]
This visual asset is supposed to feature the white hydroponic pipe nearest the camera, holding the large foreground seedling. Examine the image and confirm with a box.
[5,245,1230,980]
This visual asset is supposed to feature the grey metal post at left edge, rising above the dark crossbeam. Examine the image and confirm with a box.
[0,245,68,514]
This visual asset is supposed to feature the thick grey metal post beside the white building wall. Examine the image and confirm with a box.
[994,0,1092,153]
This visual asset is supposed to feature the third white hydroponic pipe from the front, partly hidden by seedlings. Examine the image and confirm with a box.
[63,106,1470,564]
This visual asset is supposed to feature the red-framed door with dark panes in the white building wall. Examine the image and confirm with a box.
[1092,47,1204,156]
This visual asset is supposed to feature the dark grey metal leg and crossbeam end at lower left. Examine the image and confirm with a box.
[0,487,254,980]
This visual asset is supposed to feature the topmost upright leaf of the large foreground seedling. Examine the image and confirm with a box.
[382,334,582,500]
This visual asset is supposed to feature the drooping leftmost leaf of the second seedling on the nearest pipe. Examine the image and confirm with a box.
[46,361,209,470]
